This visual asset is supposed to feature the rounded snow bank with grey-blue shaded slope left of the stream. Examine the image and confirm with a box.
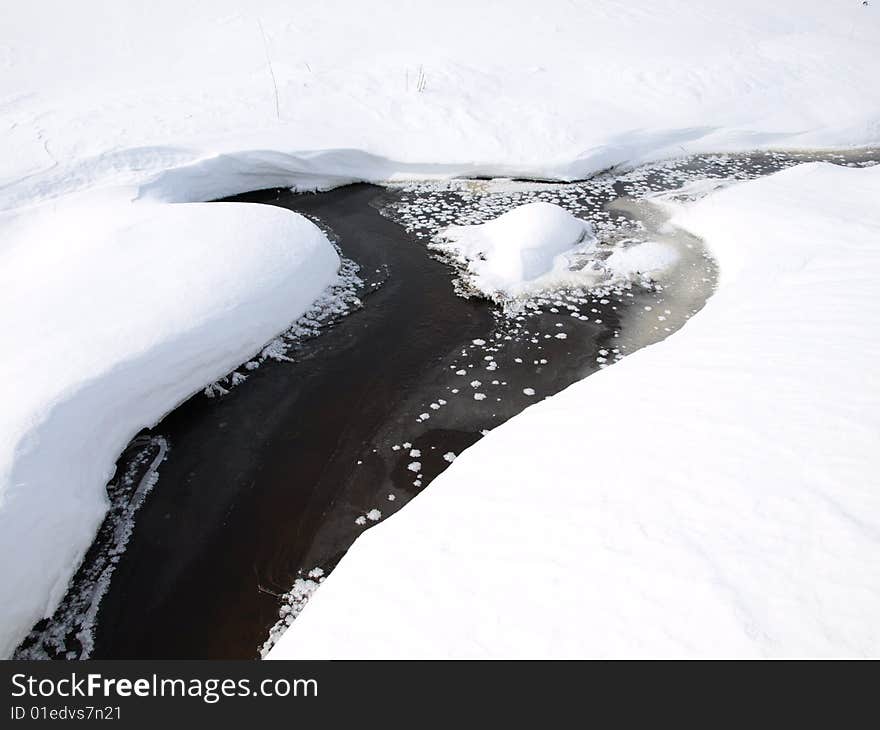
[0,199,339,656]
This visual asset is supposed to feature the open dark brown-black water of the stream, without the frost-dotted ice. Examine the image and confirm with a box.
[94,185,491,657]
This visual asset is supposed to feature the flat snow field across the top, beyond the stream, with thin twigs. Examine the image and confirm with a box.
[0,0,880,207]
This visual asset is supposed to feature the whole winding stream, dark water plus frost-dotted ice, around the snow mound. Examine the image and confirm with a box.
[18,146,878,658]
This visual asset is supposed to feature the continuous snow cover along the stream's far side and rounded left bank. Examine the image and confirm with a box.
[0,0,880,655]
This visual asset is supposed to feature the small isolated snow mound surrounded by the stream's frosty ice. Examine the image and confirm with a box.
[432,202,596,296]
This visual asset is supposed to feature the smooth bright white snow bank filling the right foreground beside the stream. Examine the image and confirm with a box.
[271,164,880,658]
